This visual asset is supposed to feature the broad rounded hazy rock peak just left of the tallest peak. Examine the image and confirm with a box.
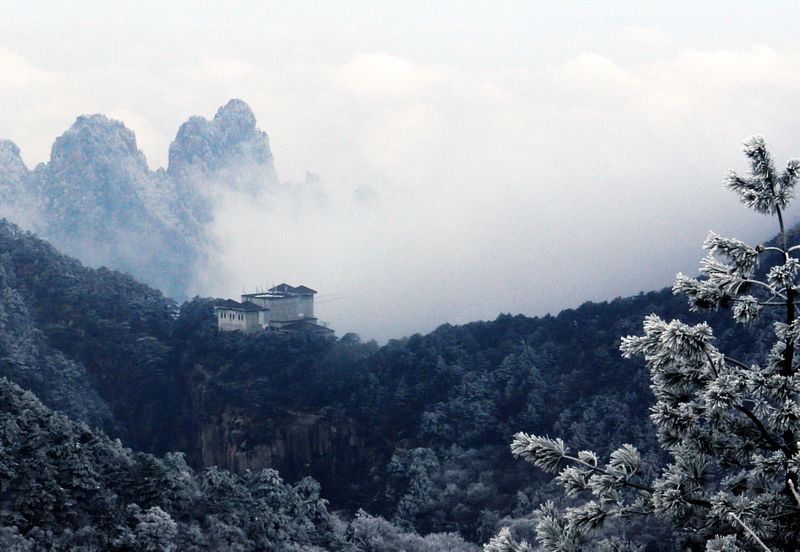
[34,115,196,296]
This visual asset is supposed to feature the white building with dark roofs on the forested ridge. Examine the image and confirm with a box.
[215,284,333,335]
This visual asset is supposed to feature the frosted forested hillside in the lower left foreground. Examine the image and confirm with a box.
[0,378,482,552]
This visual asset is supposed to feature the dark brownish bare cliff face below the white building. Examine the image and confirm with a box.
[185,358,393,505]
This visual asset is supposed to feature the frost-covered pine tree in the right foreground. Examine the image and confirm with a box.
[484,136,800,552]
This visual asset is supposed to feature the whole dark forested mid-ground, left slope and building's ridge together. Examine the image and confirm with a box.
[0,213,780,540]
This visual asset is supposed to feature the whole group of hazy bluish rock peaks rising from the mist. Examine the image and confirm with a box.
[0,100,278,299]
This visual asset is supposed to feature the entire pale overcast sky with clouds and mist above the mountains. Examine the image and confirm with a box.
[0,1,800,339]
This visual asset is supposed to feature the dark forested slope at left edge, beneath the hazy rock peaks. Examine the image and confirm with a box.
[0,221,180,450]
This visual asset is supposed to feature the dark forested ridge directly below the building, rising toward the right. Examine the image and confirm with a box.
[167,260,769,541]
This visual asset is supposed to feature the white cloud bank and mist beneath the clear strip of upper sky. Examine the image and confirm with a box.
[0,43,800,338]
